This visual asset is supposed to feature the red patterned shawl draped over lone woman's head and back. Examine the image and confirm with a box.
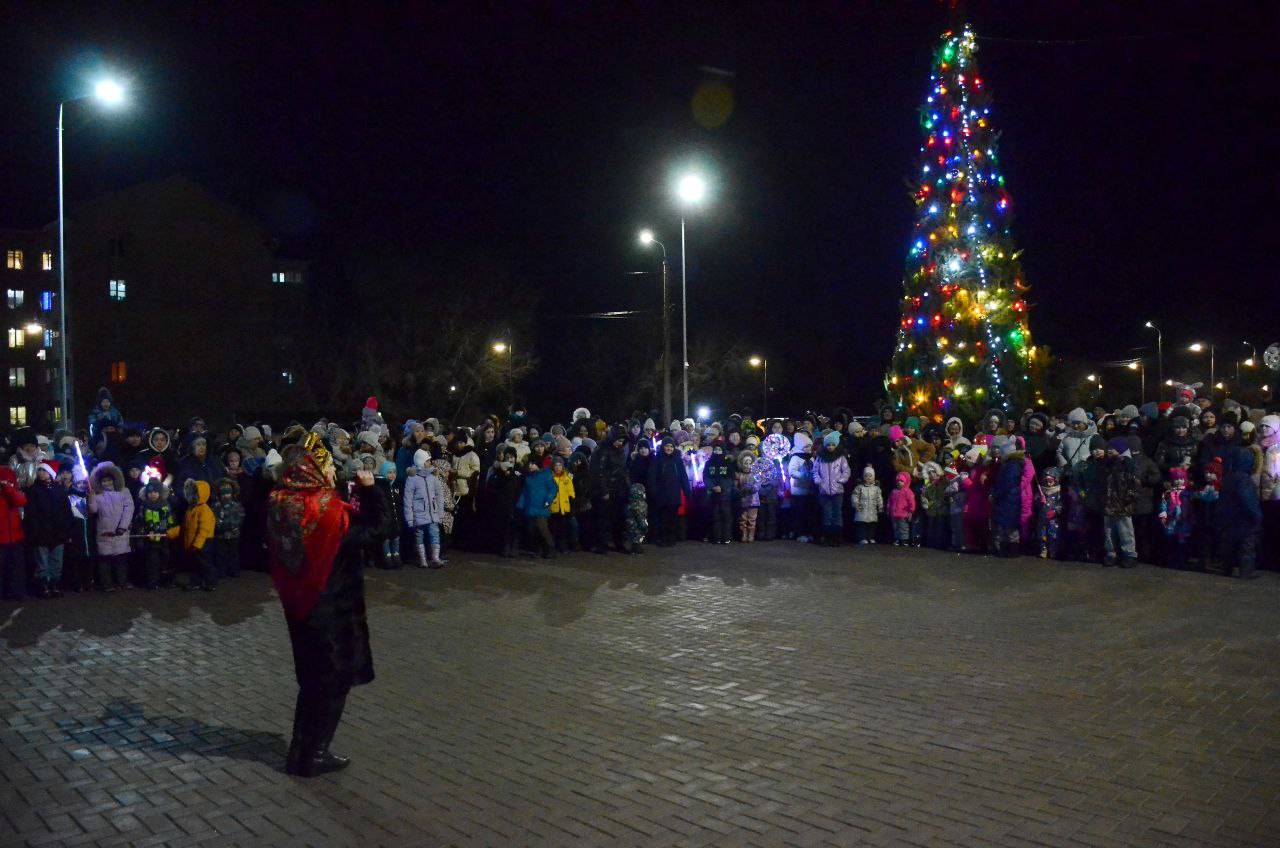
[268,452,351,621]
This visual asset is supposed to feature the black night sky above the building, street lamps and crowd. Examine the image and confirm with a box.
[0,0,1280,411]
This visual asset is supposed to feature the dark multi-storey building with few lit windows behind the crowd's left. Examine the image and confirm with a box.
[0,177,310,429]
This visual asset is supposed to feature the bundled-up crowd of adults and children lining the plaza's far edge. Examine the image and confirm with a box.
[0,386,1280,599]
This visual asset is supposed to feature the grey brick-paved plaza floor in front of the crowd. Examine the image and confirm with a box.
[0,542,1280,848]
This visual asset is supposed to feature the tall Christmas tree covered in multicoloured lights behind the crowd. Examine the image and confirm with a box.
[884,27,1044,421]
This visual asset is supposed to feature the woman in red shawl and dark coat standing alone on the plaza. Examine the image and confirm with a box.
[268,434,387,778]
